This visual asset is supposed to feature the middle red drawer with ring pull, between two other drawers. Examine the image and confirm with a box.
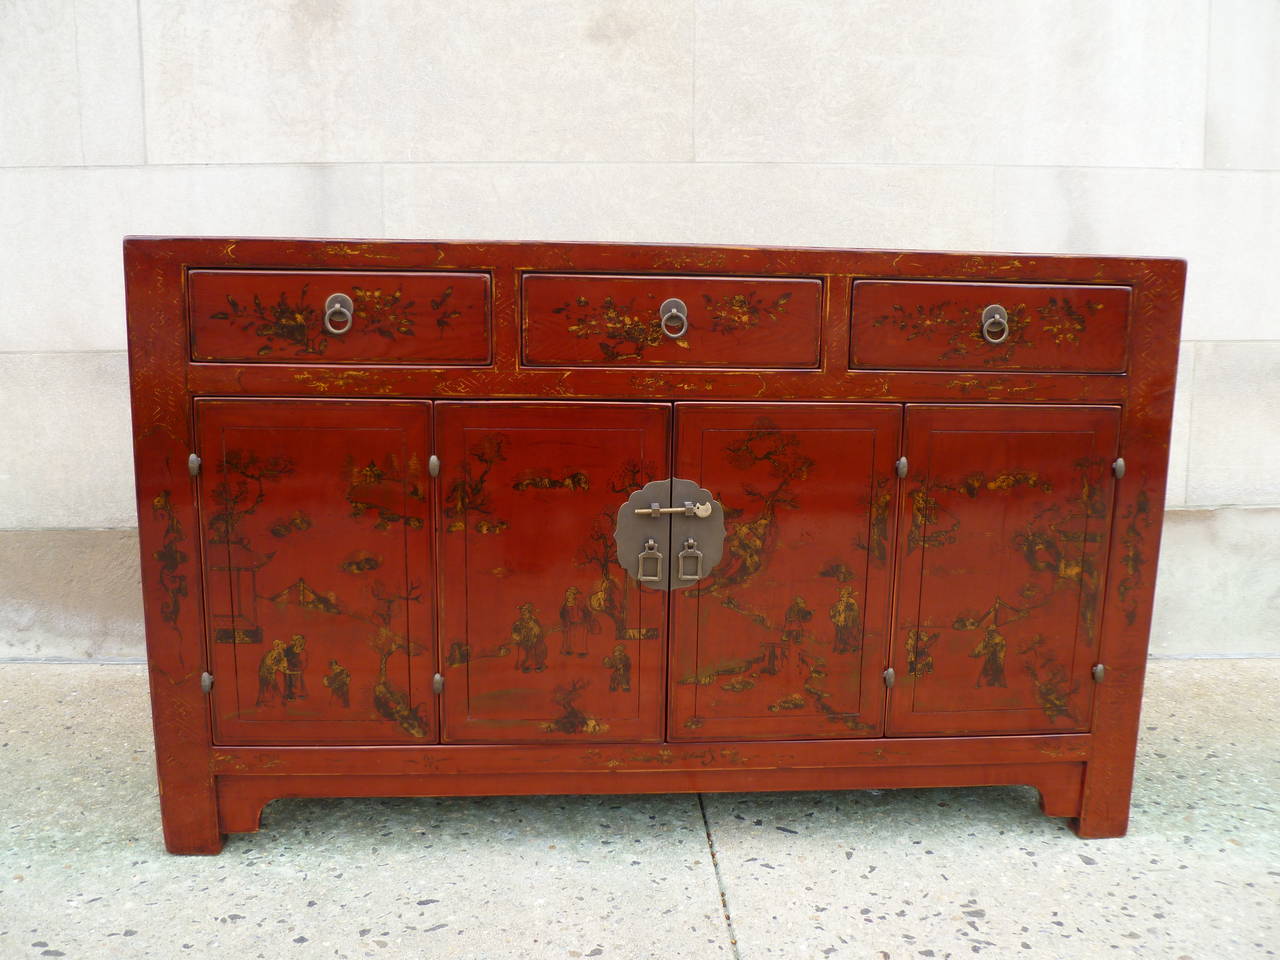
[524,274,822,367]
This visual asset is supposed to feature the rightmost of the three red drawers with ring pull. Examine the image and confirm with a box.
[850,280,1129,372]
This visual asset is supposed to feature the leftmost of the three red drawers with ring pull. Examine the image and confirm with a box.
[187,270,490,365]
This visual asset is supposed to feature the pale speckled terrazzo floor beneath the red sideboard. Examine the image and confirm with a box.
[0,659,1280,960]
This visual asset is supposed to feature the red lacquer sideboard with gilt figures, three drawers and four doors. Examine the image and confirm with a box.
[124,237,1185,854]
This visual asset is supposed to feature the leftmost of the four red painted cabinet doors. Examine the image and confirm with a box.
[196,399,436,744]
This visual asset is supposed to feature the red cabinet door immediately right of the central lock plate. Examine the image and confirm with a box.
[668,403,901,740]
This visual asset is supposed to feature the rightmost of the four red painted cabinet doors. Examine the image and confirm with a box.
[888,406,1120,733]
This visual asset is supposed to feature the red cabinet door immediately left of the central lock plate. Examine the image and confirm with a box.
[436,402,671,742]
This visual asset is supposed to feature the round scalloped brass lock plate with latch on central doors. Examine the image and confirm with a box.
[613,476,724,590]
